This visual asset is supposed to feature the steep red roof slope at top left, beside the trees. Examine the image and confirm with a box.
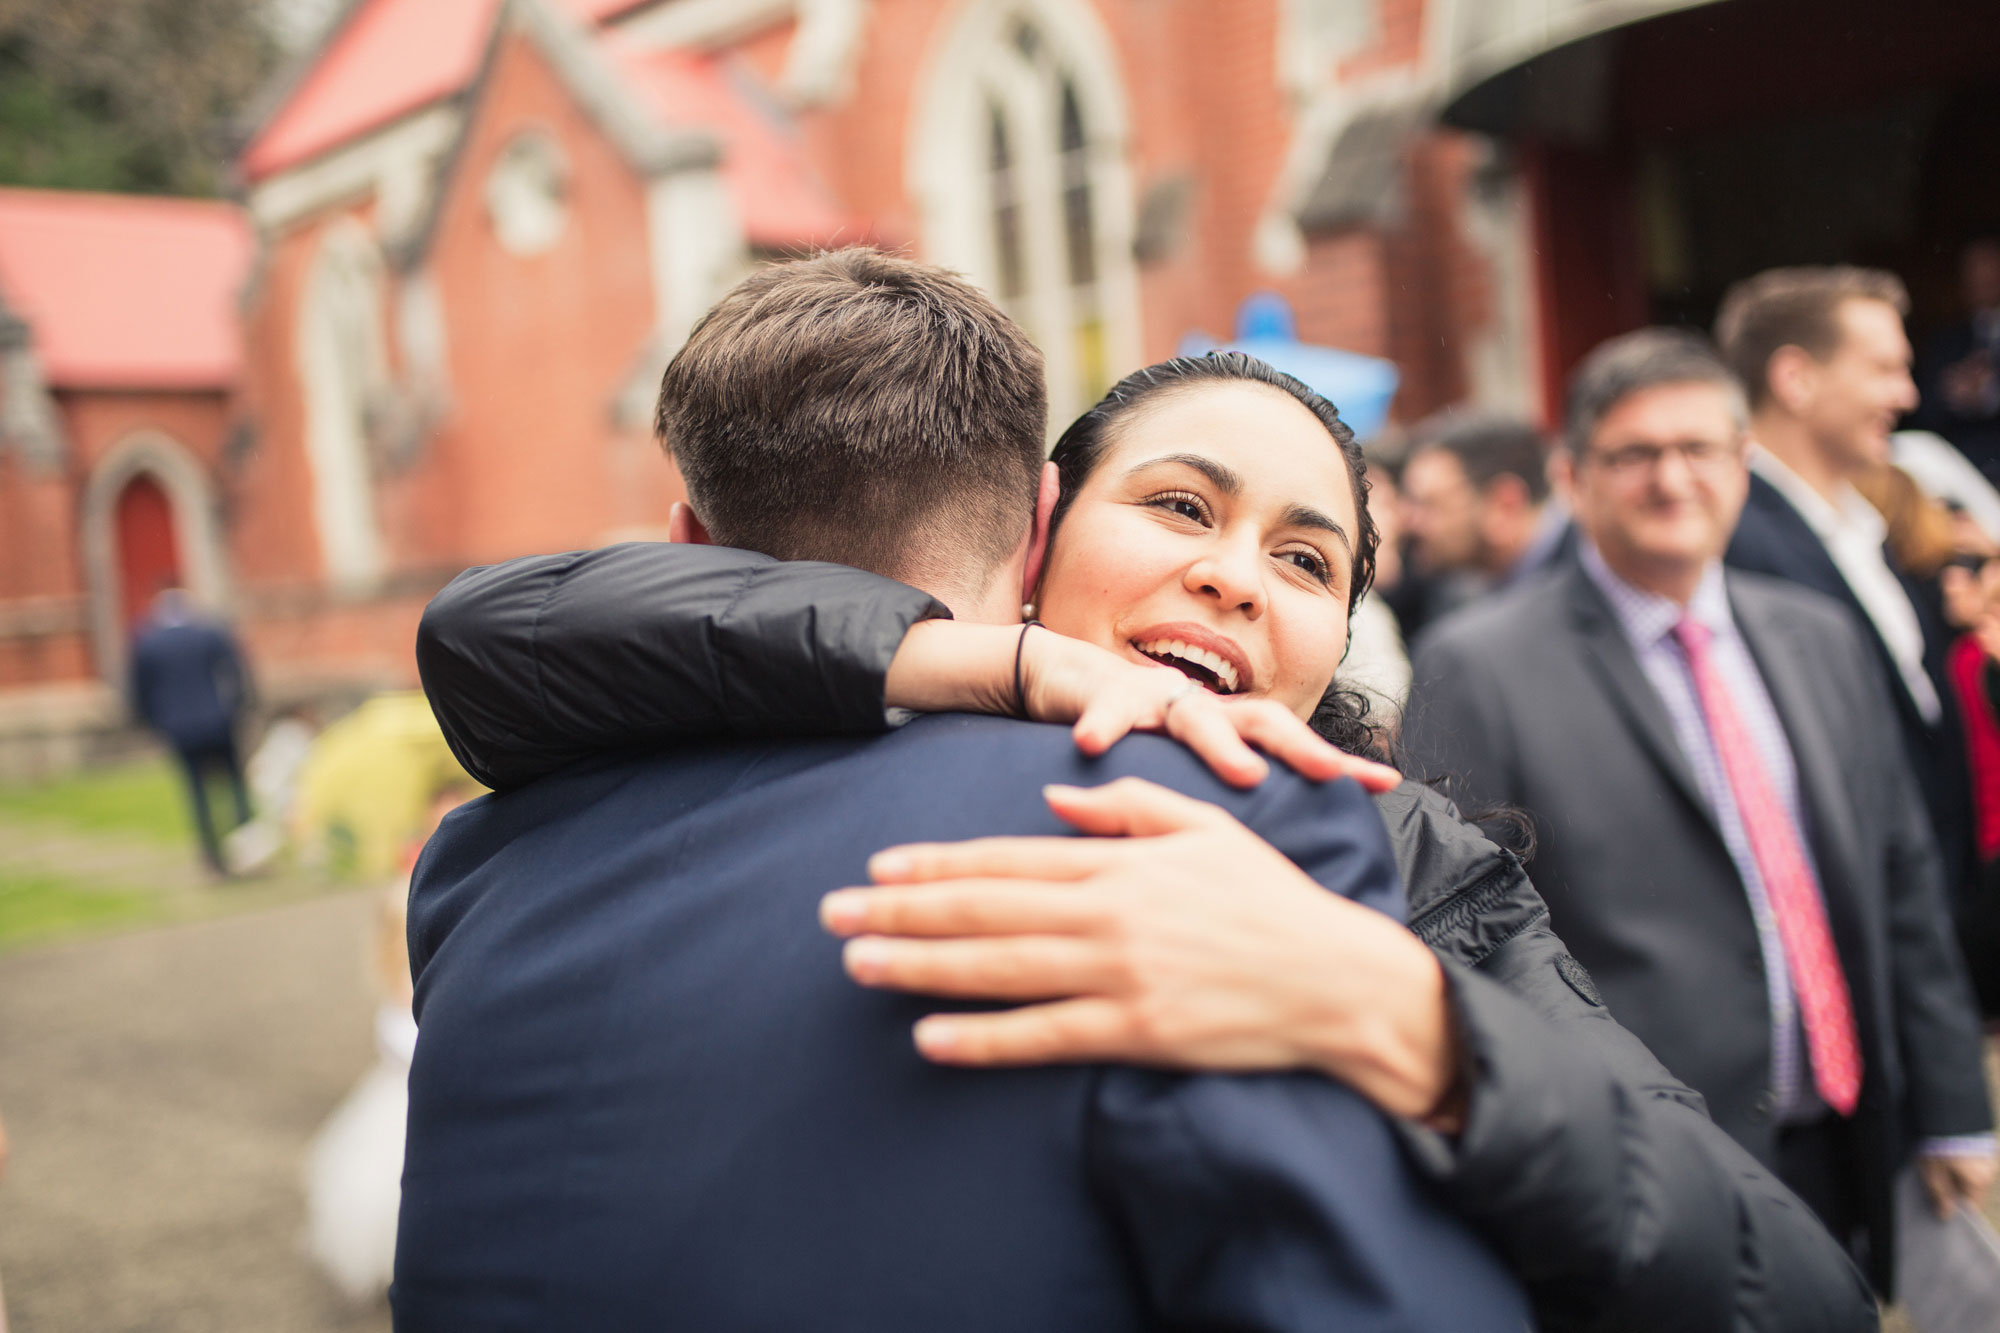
[242,0,660,180]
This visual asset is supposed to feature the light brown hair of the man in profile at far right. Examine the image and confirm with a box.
[1716,264,1910,406]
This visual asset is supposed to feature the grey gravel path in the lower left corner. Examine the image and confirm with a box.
[0,891,388,1333]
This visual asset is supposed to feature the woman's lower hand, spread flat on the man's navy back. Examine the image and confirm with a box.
[820,779,1458,1129]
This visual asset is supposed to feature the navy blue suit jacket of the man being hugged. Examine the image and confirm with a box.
[392,715,1528,1333]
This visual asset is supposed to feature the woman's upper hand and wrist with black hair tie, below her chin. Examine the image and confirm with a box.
[884,620,1402,791]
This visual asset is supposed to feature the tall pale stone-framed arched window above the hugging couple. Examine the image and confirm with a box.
[912,0,1140,428]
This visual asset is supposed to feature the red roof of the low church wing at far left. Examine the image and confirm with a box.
[0,190,252,388]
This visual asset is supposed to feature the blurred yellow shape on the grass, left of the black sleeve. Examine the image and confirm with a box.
[292,691,484,879]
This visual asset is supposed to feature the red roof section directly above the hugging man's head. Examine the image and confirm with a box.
[602,32,860,250]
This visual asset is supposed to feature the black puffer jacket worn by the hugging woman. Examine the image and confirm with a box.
[418,544,1876,1333]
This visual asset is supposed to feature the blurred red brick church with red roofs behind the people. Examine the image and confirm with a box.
[0,0,2000,768]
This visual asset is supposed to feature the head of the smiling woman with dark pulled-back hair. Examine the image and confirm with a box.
[1036,352,1378,753]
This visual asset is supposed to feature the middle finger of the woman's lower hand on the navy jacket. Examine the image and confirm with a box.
[820,879,1104,939]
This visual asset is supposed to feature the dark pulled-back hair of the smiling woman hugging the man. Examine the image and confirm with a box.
[1048,352,1388,759]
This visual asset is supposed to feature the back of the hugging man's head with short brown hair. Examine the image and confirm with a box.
[656,248,1048,576]
